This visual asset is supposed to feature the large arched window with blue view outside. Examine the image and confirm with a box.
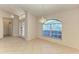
[42,19,62,39]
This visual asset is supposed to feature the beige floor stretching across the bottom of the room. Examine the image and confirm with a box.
[0,37,79,54]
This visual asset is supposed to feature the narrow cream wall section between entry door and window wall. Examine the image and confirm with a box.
[26,13,37,40]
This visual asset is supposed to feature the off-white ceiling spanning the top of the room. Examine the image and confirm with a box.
[0,4,79,16]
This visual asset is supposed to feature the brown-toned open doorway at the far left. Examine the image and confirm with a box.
[3,18,12,37]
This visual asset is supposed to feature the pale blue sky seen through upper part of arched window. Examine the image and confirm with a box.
[43,20,62,31]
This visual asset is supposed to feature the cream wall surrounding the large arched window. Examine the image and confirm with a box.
[38,8,79,49]
